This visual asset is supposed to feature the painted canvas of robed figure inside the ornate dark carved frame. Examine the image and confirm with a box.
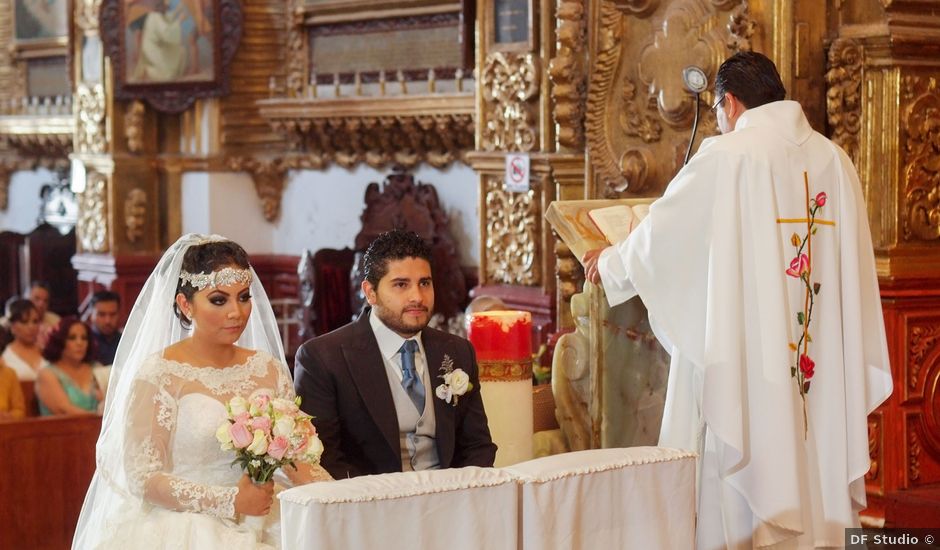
[123,0,216,84]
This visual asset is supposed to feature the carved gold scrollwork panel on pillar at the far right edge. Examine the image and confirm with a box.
[901,76,940,241]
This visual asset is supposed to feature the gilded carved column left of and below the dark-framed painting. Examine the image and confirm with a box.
[70,0,164,311]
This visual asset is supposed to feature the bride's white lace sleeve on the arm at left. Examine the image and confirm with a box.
[124,362,238,518]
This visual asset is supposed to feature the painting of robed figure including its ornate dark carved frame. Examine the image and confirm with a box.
[101,0,242,113]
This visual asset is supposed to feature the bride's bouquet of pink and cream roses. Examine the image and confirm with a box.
[215,389,323,483]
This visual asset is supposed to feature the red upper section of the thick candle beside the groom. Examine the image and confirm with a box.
[467,311,532,362]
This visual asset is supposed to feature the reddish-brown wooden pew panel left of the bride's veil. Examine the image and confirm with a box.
[0,416,101,550]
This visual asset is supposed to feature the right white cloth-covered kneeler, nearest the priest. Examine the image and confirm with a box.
[504,447,696,550]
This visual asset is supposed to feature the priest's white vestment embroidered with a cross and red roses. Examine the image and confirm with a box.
[598,101,892,550]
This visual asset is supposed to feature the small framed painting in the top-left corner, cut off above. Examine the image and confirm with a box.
[8,0,69,57]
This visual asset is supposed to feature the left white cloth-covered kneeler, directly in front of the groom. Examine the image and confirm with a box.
[279,467,519,550]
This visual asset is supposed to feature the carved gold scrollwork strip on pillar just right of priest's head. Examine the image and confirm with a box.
[826,38,862,165]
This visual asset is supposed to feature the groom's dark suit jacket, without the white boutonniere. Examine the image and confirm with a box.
[294,308,496,479]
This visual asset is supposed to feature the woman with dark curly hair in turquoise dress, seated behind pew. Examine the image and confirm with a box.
[36,317,102,416]
